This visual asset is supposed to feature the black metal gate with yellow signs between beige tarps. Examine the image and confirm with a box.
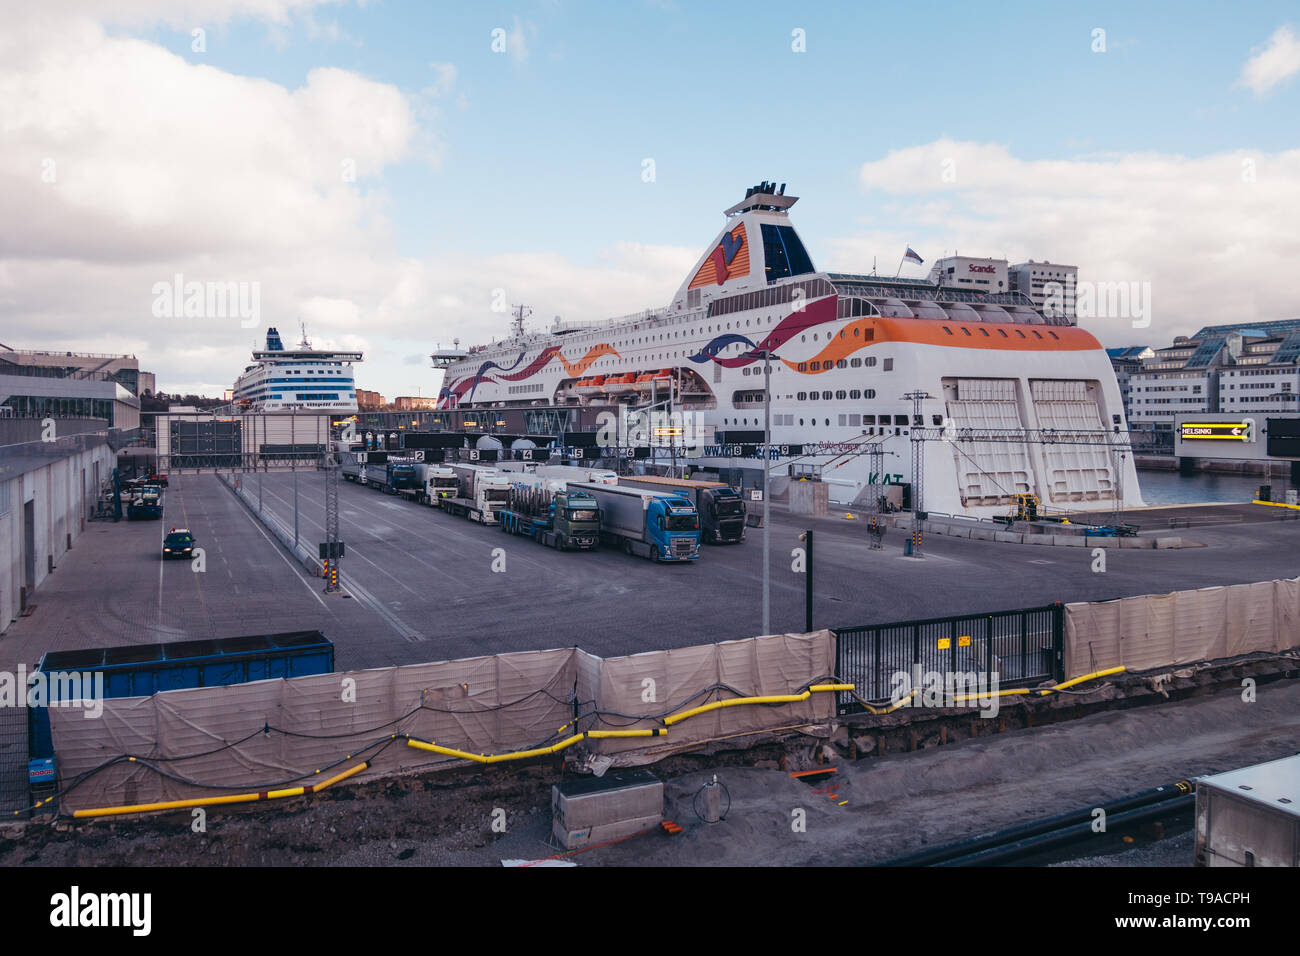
[835,604,1065,714]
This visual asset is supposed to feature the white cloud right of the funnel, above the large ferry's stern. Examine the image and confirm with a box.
[852,140,1300,345]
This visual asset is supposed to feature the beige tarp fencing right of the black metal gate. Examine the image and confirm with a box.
[1065,579,1300,678]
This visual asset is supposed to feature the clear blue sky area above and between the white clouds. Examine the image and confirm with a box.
[131,3,1300,265]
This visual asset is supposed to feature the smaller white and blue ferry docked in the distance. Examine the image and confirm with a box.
[233,328,361,415]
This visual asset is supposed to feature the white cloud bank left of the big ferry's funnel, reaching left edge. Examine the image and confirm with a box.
[0,7,698,395]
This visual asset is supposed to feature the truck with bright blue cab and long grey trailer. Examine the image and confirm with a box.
[568,481,699,561]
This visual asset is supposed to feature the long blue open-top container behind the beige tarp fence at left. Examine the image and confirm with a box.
[27,631,334,805]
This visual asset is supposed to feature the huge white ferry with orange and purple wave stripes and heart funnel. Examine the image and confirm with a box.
[436,182,1141,515]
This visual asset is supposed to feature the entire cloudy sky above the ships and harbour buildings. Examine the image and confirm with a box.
[0,0,1300,398]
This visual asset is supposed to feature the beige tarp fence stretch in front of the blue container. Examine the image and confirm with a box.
[49,648,576,810]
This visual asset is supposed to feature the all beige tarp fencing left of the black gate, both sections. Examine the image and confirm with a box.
[49,631,835,812]
